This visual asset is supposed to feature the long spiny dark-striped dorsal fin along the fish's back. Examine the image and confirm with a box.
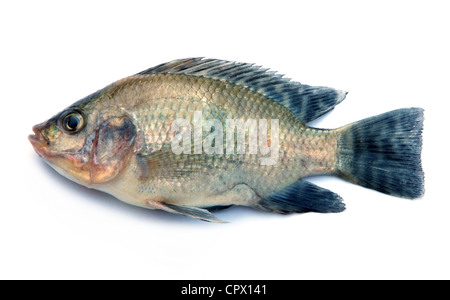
[136,57,347,123]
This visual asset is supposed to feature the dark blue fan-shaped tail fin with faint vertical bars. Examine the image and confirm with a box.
[337,108,424,199]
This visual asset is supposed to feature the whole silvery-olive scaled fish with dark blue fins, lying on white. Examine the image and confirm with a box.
[29,57,424,222]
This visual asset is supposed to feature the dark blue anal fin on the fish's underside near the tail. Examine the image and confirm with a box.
[257,180,345,214]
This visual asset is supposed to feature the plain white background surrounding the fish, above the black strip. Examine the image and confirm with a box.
[0,0,450,279]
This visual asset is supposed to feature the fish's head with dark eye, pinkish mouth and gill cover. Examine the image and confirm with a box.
[28,106,136,187]
